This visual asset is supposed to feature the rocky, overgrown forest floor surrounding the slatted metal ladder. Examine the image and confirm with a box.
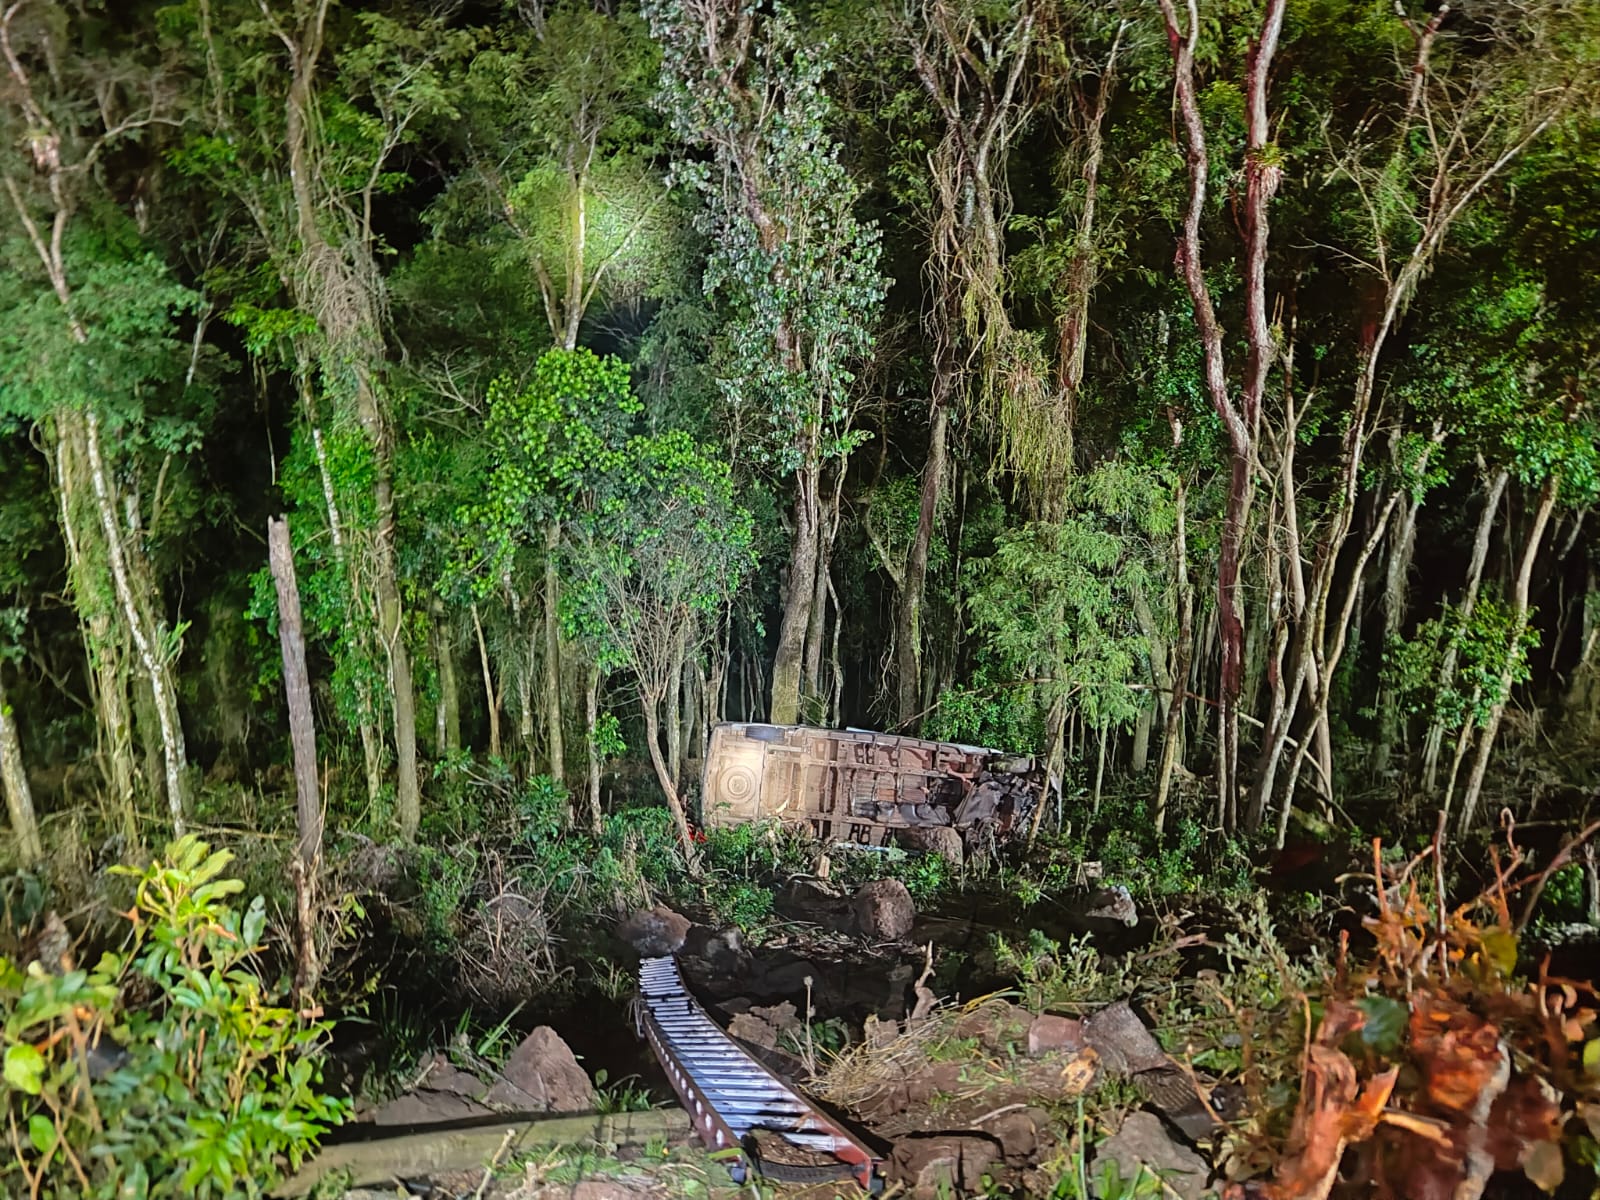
[0,774,1600,1200]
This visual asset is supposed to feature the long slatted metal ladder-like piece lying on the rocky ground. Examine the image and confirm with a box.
[638,957,883,1192]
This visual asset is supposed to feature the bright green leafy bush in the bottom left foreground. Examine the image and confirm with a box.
[0,837,347,1200]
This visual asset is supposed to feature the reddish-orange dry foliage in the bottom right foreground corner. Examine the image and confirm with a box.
[1226,840,1600,1200]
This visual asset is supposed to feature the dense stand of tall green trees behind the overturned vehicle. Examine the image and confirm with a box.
[0,0,1600,866]
